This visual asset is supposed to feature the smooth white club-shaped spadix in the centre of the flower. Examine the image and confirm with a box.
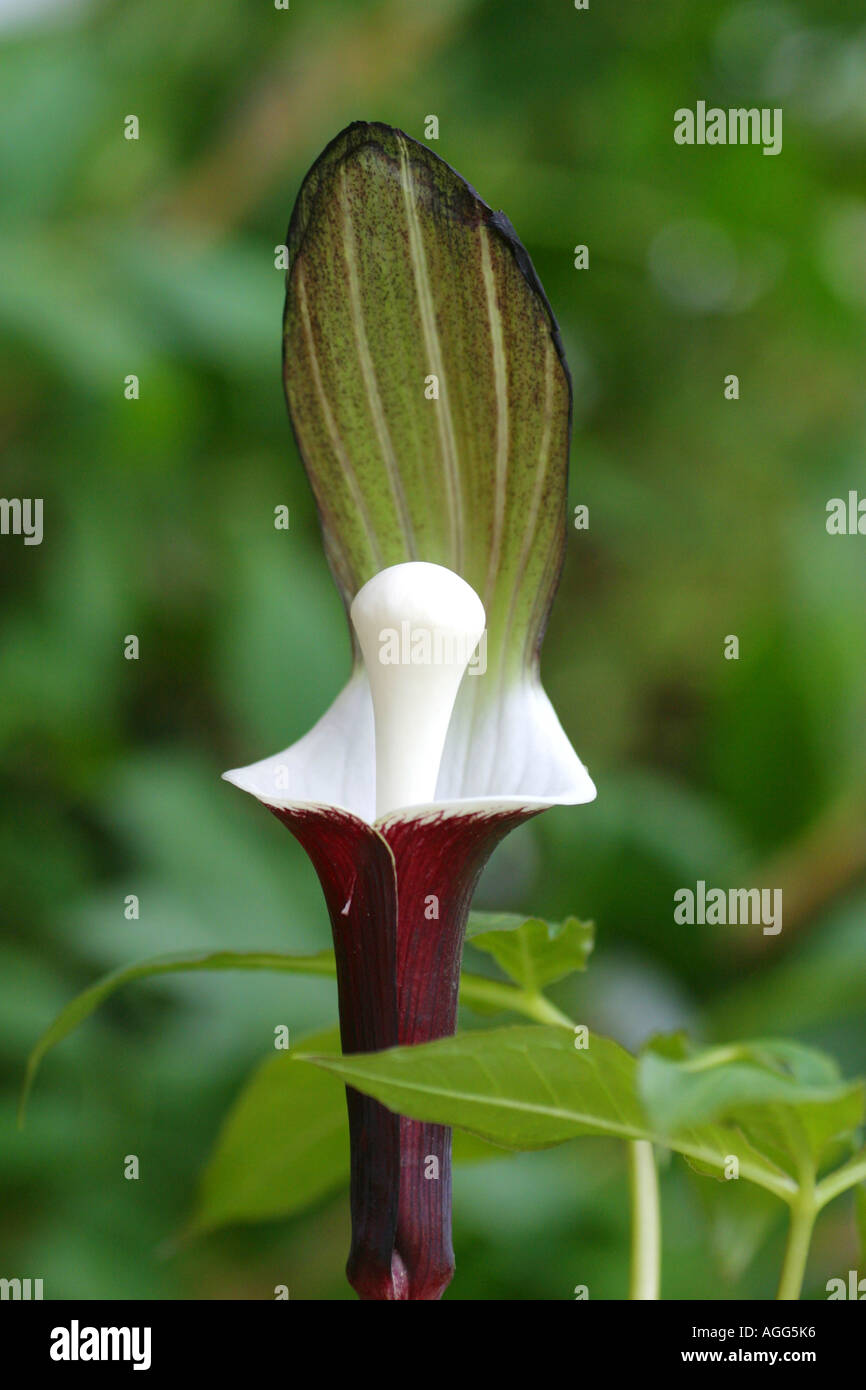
[350,560,485,819]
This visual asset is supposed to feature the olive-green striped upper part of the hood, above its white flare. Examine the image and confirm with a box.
[285,122,571,688]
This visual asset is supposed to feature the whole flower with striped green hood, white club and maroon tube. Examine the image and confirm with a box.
[225,122,595,1300]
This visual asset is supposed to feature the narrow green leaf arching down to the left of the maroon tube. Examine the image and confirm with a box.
[18,951,335,1123]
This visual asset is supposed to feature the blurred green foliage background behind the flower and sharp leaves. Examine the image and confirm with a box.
[0,0,866,1300]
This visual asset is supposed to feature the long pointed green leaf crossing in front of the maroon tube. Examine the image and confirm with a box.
[297,1027,796,1200]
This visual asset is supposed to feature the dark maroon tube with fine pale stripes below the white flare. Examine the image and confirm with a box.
[271,808,535,1301]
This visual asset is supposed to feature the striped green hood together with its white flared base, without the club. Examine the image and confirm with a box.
[227,122,595,821]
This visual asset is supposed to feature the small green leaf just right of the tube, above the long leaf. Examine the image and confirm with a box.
[471,913,595,991]
